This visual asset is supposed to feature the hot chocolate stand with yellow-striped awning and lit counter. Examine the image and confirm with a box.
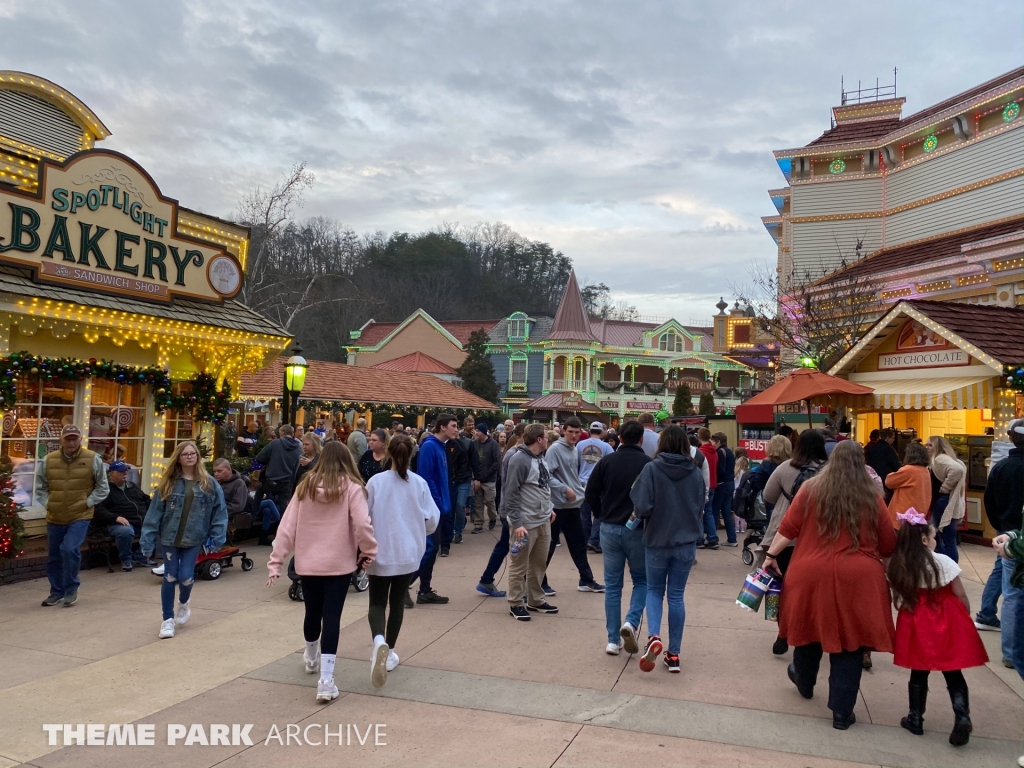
[829,301,1024,537]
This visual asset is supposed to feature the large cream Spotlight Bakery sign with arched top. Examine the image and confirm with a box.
[0,150,242,302]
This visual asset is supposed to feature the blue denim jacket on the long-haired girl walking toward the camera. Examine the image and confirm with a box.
[138,477,227,555]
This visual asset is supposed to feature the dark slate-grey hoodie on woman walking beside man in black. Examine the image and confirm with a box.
[630,454,707,548]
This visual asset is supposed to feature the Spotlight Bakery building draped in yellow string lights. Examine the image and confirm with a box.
[0,72,290,532]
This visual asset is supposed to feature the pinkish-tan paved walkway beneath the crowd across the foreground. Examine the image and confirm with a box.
[0,534,1024,768]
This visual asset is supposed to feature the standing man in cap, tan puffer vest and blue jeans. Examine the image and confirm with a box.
[36,424,110,608]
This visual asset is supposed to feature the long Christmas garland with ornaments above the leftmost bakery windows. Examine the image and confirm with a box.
[0,352,172,414]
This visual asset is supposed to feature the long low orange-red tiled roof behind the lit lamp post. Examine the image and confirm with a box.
[239,357,498,411]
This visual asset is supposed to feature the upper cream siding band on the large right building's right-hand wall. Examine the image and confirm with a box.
[884,123,1024,208]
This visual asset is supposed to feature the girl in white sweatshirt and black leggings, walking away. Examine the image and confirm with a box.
[367,435,440,688]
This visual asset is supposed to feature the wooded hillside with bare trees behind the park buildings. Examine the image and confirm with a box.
[241,217,571,360]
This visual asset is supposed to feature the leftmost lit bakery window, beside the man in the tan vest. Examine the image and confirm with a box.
[0,375,76,507]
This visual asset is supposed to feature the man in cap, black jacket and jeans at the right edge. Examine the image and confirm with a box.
[975,419,1024,667]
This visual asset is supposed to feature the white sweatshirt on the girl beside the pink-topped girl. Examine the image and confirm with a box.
[367,469,440,577]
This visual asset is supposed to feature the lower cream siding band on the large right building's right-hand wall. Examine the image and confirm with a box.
[886,174,1024,248]
